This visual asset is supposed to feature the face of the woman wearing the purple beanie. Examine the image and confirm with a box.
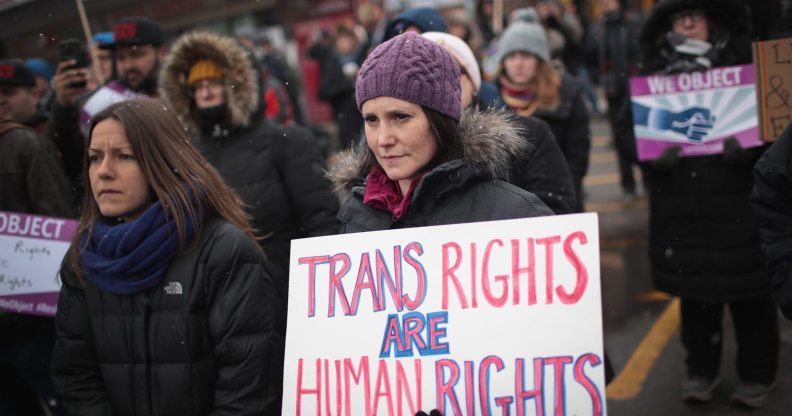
[361,97,438,194]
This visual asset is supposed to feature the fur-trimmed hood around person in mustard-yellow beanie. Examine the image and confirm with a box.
[159,31,261,132]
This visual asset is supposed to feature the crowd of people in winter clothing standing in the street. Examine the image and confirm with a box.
[0,0,792,415]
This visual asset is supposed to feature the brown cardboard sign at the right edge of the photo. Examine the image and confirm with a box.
[753,38,792,141]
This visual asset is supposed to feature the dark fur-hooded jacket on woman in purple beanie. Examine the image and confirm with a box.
[329,110,553,233]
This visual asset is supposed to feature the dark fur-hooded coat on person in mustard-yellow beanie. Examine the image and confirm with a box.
[160,32,338,299]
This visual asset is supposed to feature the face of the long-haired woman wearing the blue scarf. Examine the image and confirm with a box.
[88,119,151,220]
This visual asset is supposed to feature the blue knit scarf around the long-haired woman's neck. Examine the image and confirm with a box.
[80,201,195,295]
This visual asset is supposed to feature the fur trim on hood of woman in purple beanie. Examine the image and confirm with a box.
[327,109,534,201]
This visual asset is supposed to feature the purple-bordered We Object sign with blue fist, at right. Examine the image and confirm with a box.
[630,65,762,160]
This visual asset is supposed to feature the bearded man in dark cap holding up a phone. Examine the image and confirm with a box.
[50,16,165,211]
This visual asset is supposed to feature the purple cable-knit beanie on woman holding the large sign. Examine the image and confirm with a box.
[355,32,462,121]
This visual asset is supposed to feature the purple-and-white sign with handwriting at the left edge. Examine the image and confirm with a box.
[0,211,79,316]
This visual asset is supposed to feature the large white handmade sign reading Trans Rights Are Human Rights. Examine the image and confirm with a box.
[282,214,606,416]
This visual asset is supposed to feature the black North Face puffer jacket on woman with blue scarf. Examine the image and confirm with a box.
[52,219,284,416]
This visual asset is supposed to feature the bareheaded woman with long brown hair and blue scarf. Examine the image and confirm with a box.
[53,100,283,415]
